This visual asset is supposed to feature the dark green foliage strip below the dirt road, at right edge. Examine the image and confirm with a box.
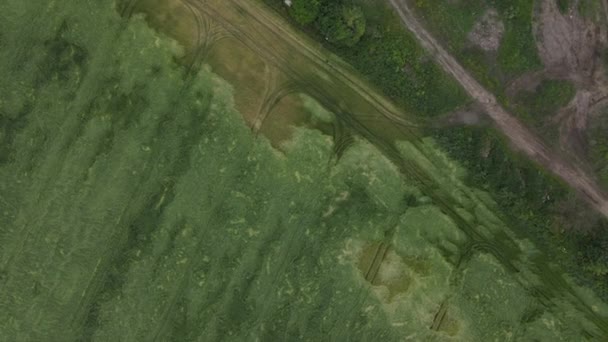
[434,127,608,298]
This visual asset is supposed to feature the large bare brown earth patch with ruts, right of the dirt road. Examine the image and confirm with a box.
[536,0,608,164]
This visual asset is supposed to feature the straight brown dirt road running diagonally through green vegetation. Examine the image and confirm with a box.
[389,0,608,217]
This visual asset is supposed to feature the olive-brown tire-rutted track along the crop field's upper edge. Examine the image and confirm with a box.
[183,0,608,332]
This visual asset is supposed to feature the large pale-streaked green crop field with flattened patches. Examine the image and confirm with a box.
[0,0,608,342]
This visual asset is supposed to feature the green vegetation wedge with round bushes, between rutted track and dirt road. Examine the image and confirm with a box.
[264,0,468,118]
